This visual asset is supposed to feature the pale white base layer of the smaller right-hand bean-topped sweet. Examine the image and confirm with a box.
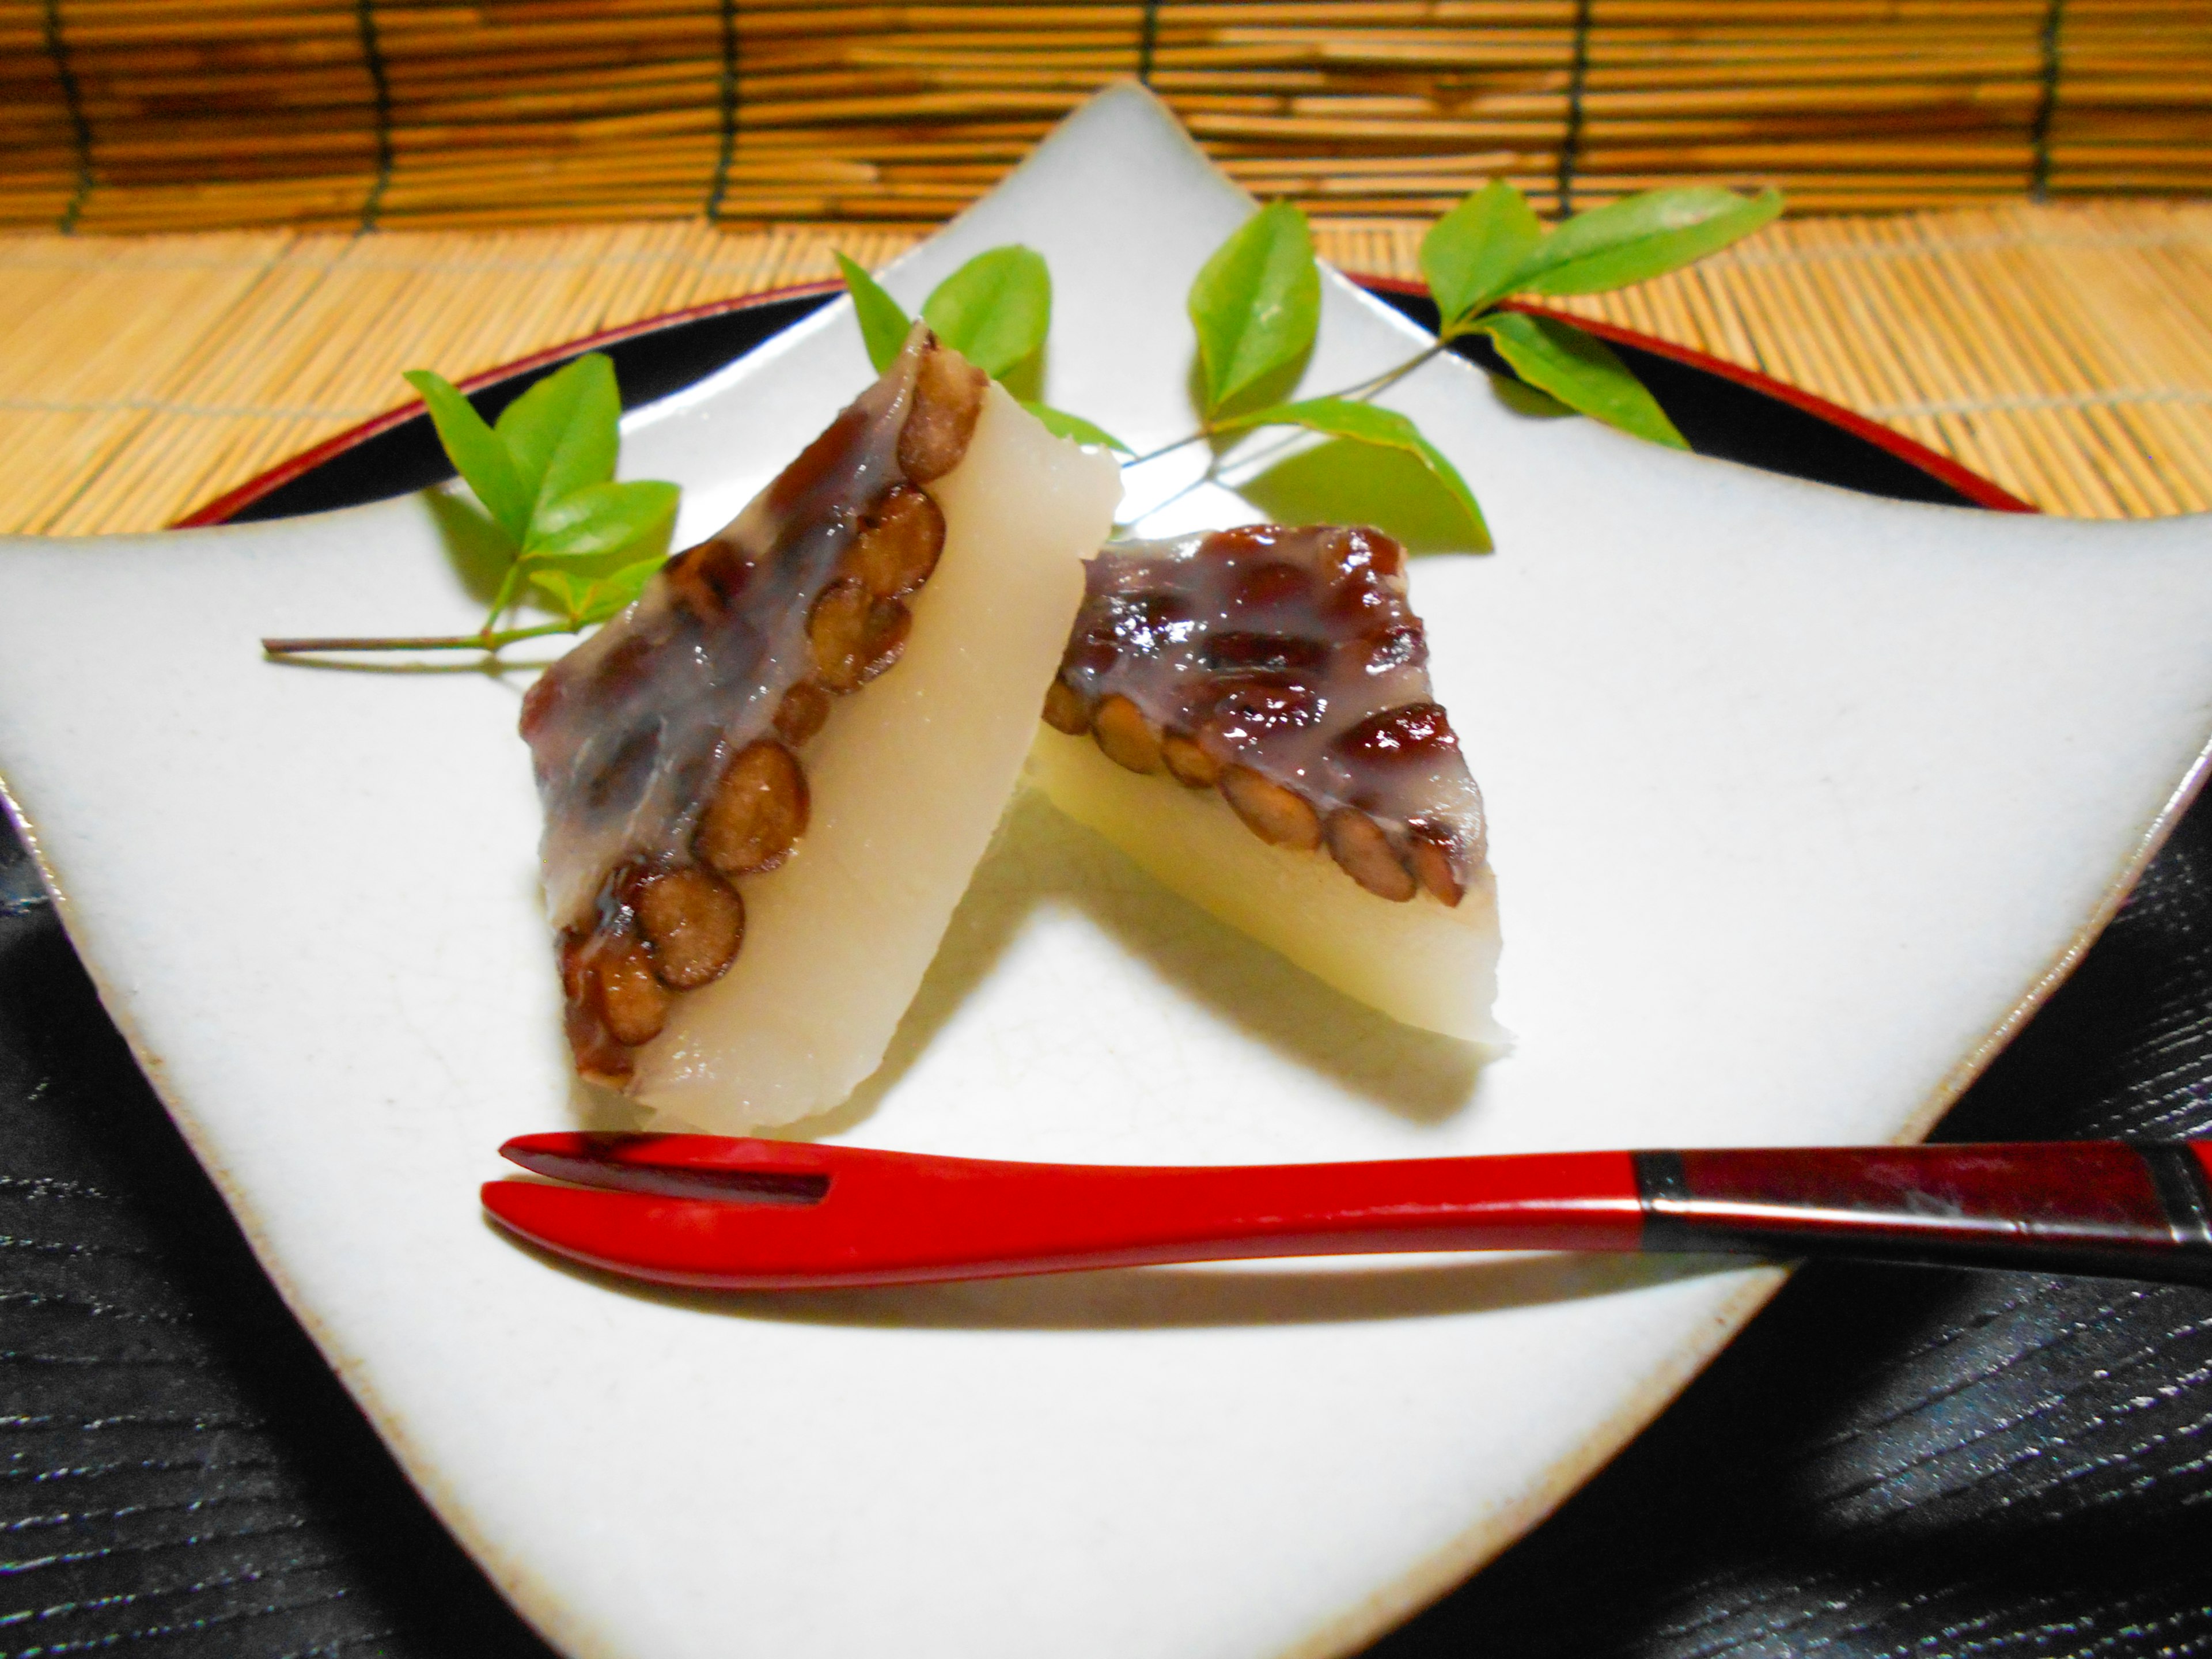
[1029,726,1509,1053]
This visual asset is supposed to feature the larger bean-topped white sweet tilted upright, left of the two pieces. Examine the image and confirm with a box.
[522,325,1122,1130]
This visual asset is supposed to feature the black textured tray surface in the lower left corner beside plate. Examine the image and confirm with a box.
[0,819,551,1659]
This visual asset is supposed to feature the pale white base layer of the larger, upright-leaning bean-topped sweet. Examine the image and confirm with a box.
[630,385,1122,1132]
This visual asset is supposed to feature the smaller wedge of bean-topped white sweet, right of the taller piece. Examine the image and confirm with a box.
[1031,524,1502,1046]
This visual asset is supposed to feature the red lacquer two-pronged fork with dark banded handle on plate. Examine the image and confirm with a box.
[484,1135,2212,1290]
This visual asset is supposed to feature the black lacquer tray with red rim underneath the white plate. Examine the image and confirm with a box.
[0,283,2212,1659]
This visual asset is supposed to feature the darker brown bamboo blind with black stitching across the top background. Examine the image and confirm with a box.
[0,0,2212,230]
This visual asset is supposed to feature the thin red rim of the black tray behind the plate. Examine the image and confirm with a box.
[171,276,2037,531]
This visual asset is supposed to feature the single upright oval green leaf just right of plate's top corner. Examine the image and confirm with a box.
[1190,201,1320,421]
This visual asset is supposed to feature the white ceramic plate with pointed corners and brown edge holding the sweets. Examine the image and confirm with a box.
[0,89,2212,1659]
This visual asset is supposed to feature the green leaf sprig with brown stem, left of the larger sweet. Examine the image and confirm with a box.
[261,352,677,657]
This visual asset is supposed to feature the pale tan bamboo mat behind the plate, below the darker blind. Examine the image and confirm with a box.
[0,203,2212,535]
